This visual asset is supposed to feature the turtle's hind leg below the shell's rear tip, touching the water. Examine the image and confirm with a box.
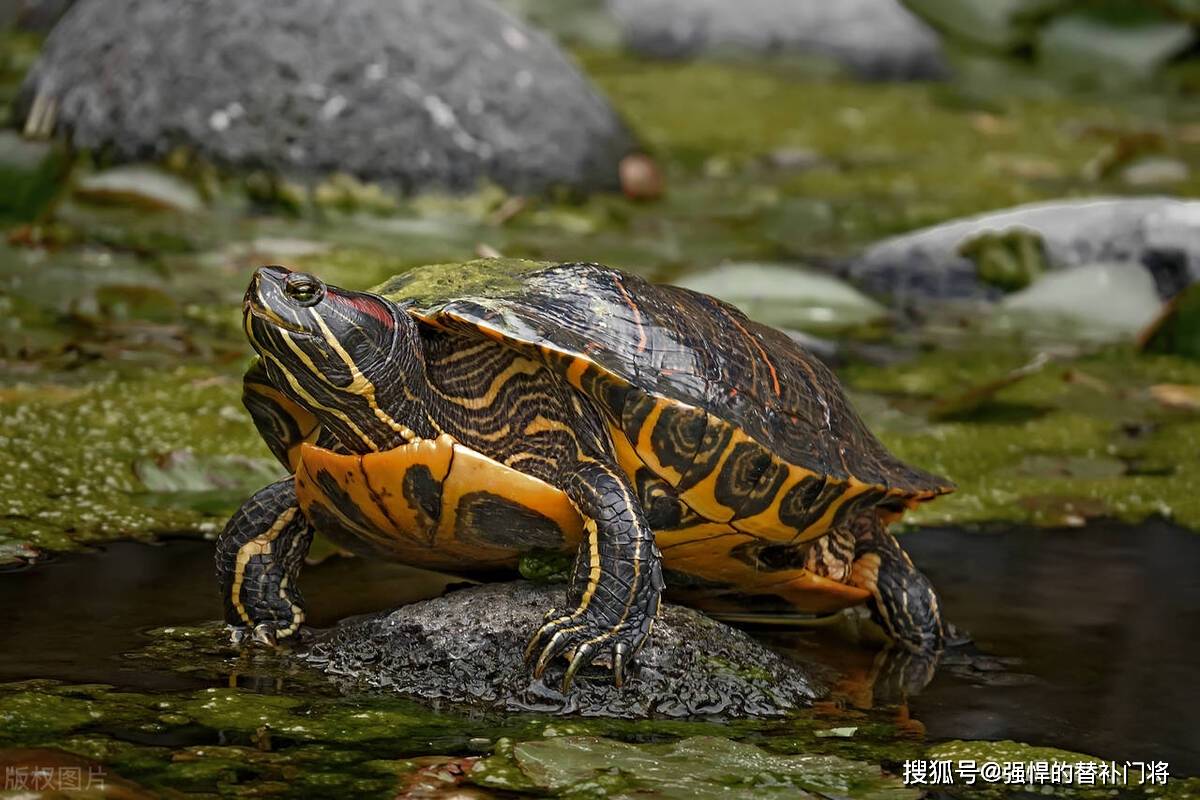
[850,512,944,652]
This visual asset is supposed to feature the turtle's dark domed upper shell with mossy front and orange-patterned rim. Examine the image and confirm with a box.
[374,259,953,543]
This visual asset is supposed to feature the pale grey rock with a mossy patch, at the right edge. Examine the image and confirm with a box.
[841,197,1200,306]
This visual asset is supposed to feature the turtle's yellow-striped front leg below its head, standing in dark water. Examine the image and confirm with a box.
[216,477,313,644]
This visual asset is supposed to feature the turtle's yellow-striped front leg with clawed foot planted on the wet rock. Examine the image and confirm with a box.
[526,461,664,692]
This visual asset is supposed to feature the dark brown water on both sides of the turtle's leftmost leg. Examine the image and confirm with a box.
[0,540,451,690]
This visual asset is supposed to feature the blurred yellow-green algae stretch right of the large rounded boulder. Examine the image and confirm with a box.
[582,53,1200,244]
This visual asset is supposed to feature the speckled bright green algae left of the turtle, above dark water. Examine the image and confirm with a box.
[0,367,269,563]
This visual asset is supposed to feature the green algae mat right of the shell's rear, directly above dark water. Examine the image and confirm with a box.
[846,348,1200,528]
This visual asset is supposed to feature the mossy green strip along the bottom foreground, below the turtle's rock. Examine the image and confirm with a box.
[0,671,1171,799]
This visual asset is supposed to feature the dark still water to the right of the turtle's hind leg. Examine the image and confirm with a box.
[904,522,1200,775]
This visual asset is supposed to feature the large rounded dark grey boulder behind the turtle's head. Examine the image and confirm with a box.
[18,0,634,191]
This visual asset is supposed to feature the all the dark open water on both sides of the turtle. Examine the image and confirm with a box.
[0,522,1200,775]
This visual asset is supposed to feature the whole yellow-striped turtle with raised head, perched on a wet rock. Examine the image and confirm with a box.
[216,258,954,691]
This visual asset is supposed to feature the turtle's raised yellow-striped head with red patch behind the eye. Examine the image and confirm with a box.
[242,266,425,452]
